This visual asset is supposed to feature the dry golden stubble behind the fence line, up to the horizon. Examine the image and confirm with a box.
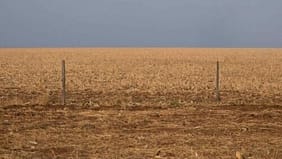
[0,49,282,106]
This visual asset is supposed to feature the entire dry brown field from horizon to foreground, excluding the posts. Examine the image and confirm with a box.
[0,48,282,159]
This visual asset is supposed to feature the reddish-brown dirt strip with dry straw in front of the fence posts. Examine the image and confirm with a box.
[0,105,282,159]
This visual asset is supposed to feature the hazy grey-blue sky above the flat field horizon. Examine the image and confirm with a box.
[0,0,282,47]
